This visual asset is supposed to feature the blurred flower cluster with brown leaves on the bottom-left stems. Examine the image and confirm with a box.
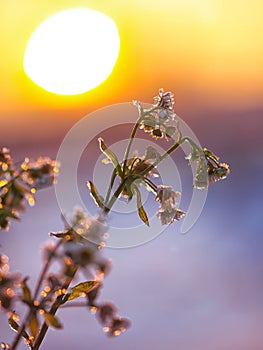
[0,209,130,348]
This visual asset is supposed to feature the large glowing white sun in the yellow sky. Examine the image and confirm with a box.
[24,8,120,95]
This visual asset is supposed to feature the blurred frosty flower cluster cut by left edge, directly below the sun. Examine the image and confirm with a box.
[0,148,58,229]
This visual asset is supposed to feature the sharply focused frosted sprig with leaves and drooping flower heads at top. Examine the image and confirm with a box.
[91,89,230,225]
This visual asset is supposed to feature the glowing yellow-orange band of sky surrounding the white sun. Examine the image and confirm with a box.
[0,0,263,127]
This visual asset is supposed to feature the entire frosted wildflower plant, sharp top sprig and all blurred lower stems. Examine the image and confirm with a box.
[0,89,230,349]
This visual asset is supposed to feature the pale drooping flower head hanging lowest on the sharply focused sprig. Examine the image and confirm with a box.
[155,185,185,225]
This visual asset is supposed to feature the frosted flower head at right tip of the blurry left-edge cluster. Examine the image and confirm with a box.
[21,157,59,189]
